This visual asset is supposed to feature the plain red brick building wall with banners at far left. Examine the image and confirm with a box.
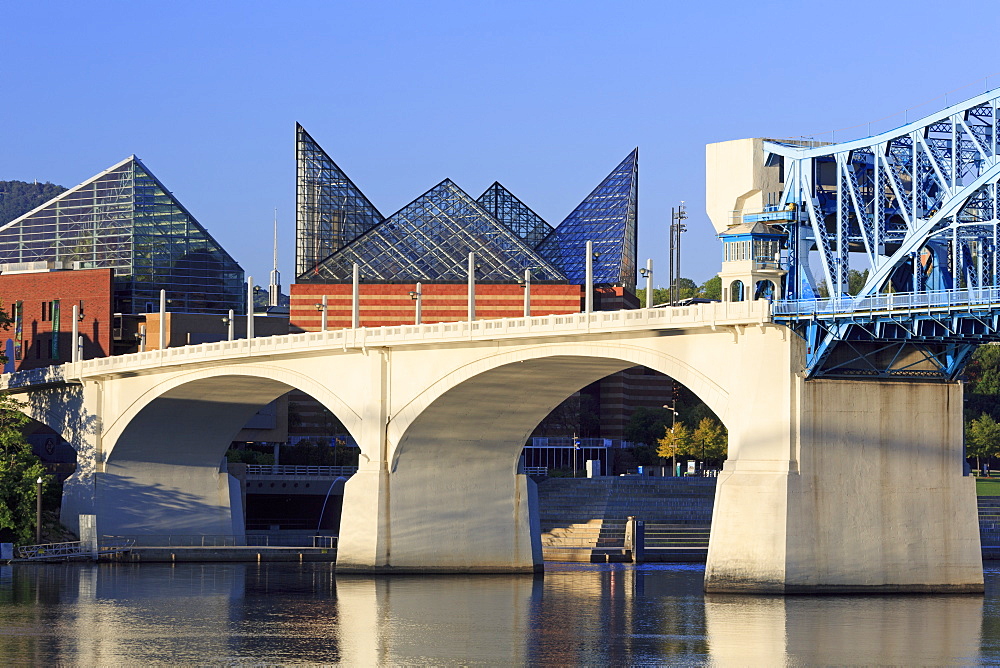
[0,269,113,369]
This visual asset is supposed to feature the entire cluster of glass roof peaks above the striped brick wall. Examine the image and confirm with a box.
[296,125,639,290]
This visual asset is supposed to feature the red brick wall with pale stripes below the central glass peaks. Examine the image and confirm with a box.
[289,283,581,332]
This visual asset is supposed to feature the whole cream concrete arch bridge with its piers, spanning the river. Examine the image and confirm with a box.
[3,301,983,591]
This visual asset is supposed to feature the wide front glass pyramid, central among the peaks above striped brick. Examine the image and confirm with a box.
[310,179,565,282]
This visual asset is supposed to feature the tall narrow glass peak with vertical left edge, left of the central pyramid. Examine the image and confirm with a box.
[295,123,385,277]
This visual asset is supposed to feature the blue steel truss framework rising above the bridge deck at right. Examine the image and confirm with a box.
[764,89,1000,299]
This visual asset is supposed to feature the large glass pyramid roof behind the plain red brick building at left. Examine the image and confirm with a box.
[0,155,244,314]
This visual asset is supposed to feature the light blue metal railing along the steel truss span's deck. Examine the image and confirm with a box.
[771,286,1000,317]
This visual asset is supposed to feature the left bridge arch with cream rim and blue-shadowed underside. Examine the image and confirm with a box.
[84,364,360,543]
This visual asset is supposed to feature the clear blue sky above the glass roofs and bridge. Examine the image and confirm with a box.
[0,0,1000,290]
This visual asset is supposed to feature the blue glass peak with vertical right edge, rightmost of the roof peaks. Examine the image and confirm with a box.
[538,148,639,290]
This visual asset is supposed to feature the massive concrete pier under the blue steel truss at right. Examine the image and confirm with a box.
[705,375,983,593]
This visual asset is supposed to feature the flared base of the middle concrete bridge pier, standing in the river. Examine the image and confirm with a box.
[337,462,542,573]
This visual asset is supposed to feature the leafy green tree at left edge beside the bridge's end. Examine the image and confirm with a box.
[0,394,51,544]
